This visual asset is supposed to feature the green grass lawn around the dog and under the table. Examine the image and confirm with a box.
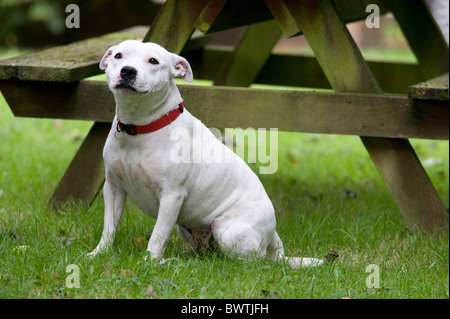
[0,65,449,299]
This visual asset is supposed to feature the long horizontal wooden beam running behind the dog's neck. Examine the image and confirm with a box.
[0,81,449,140]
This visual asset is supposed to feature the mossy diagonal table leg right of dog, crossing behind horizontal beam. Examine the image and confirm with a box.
[285,0,448,231]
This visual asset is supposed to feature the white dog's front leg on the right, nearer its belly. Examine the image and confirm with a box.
[147,192,186,259]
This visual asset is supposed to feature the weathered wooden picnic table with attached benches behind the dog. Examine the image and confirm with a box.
[0,0,449,230]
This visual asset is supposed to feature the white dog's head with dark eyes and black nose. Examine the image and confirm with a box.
[99,40,193,95]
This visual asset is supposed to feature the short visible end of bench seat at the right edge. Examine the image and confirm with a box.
[409,73,449,101]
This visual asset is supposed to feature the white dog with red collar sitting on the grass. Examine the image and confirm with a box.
[90,40,322,268]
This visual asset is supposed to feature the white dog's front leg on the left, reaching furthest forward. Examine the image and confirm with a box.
[88,178,127,257]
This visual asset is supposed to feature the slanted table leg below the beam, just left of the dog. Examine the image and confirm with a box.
[49,123,111,207]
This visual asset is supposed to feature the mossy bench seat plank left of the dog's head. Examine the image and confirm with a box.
[0,26,148,82]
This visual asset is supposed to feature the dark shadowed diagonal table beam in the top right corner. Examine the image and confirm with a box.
[385,0,449,79]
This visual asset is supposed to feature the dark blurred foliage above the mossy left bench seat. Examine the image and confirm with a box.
[0,0,161,48]
